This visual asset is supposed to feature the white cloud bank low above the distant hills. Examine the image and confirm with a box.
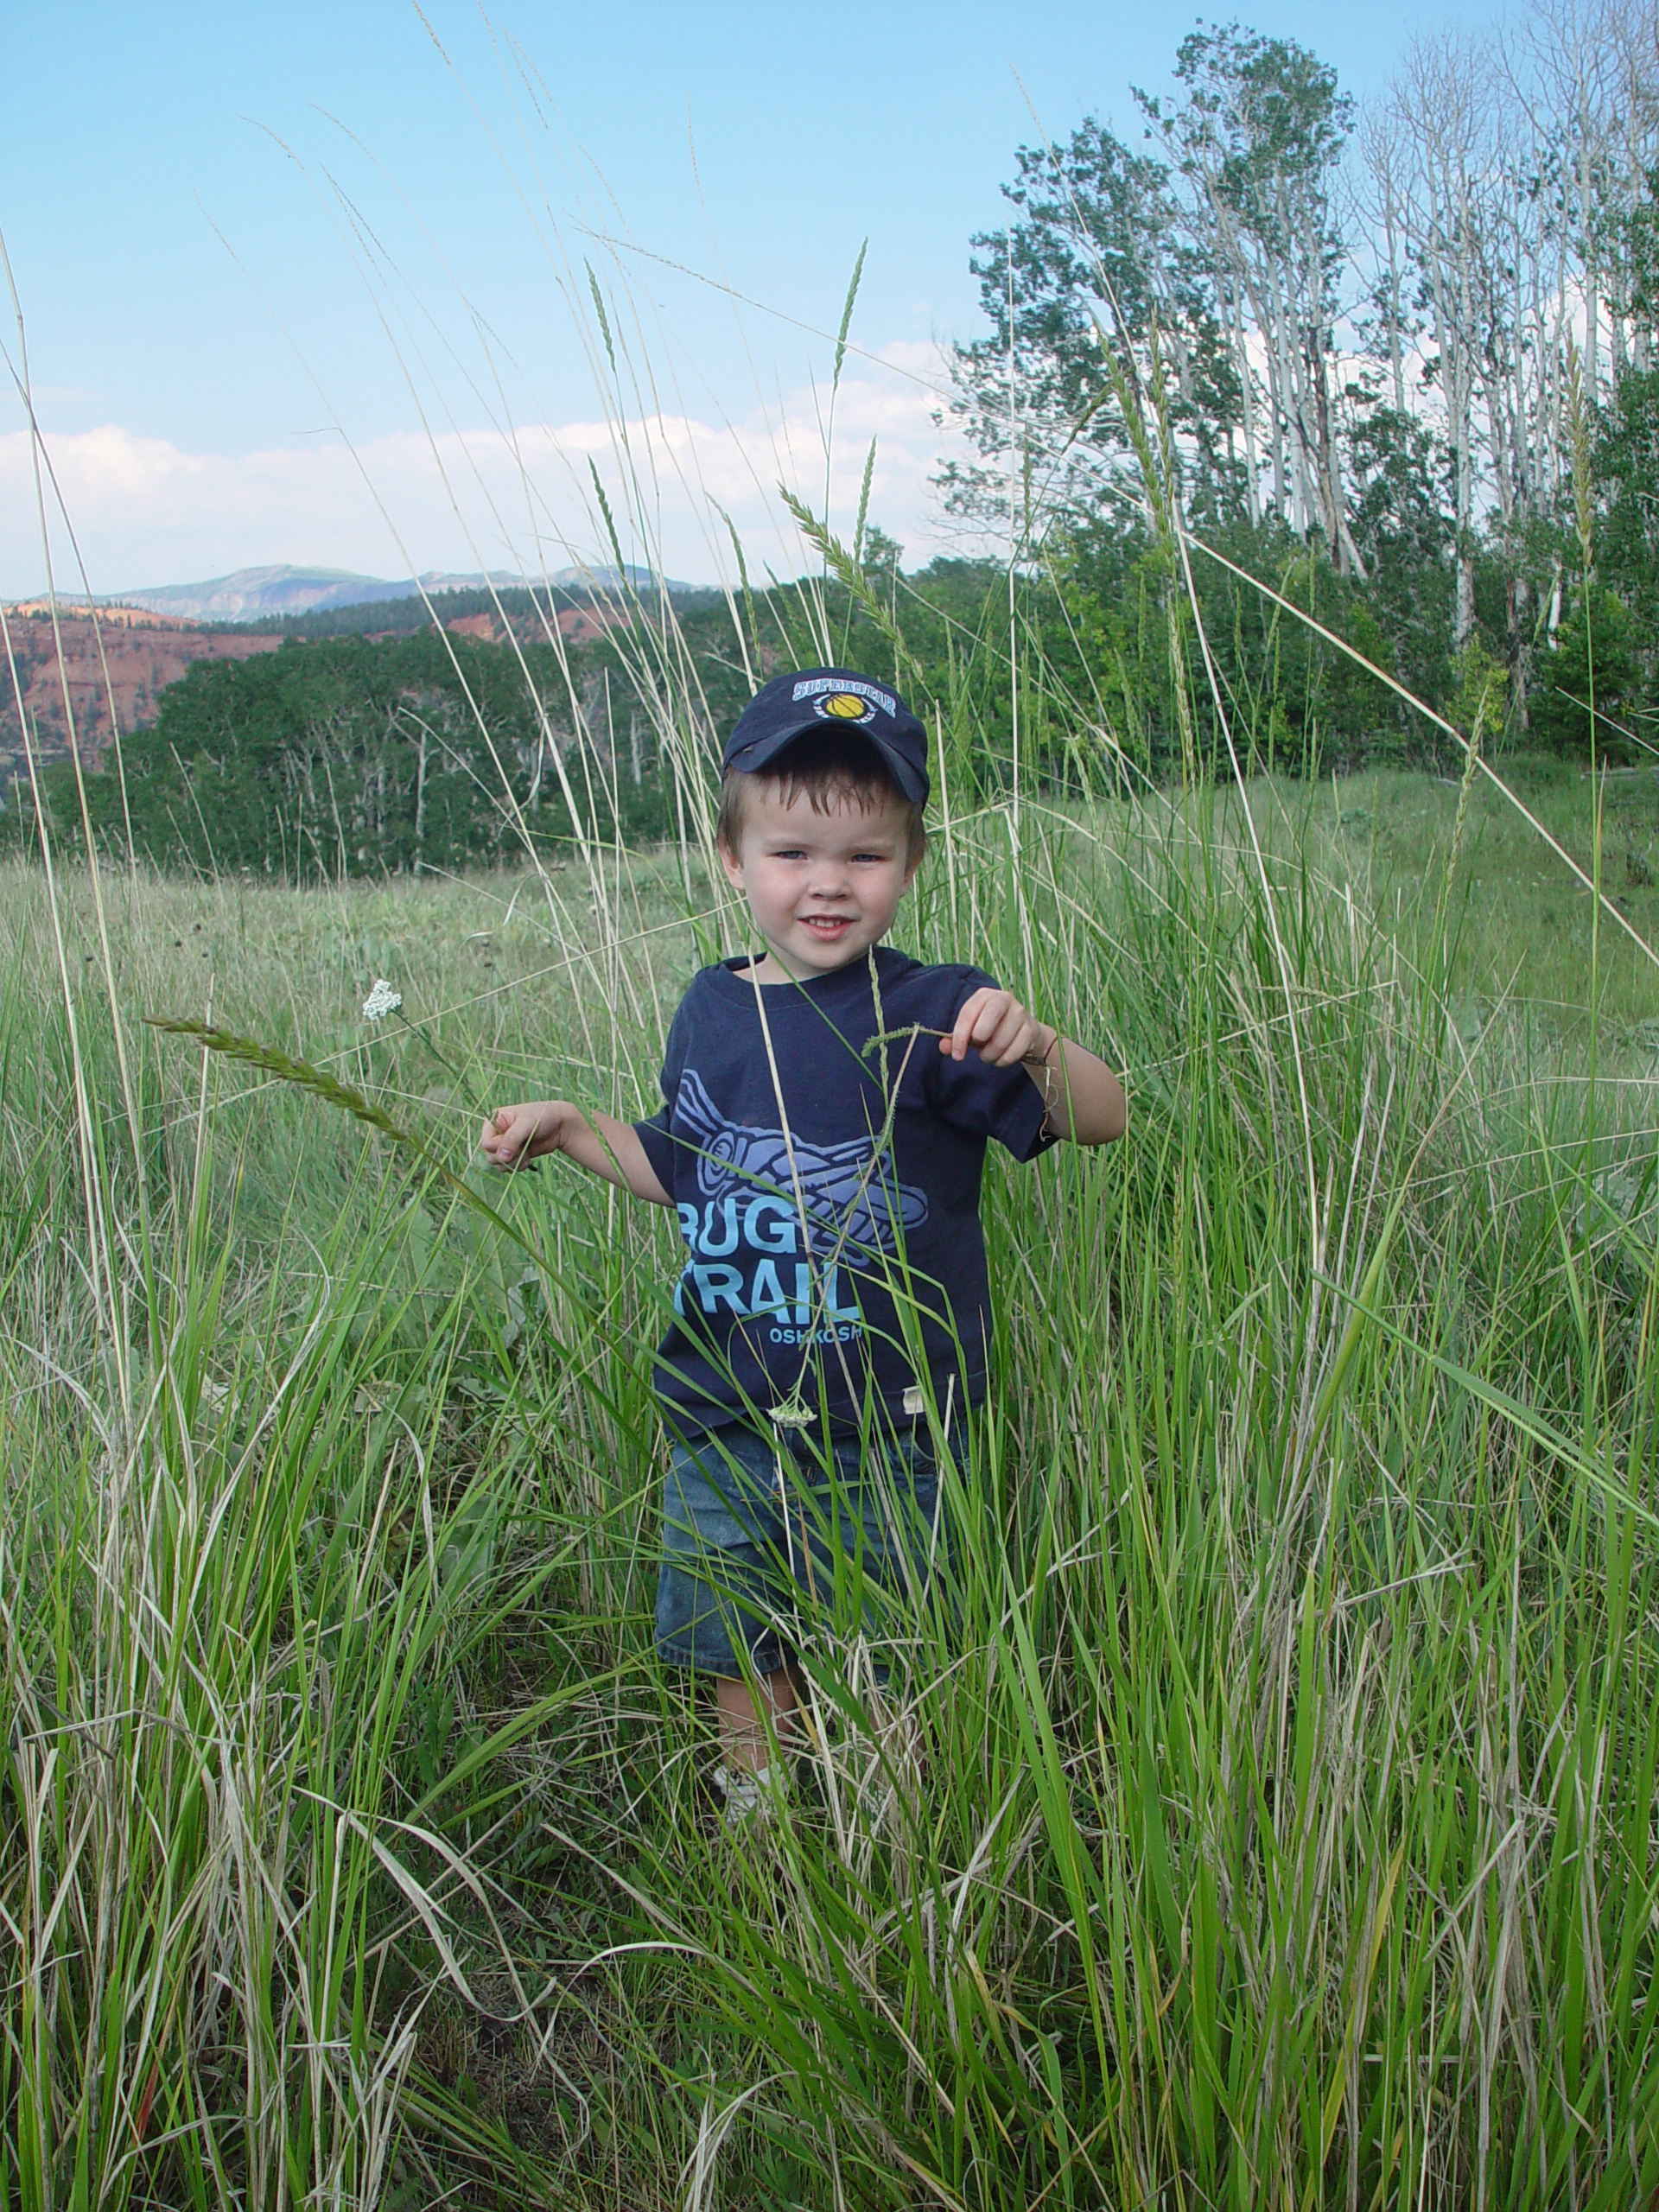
[0,343,982,597]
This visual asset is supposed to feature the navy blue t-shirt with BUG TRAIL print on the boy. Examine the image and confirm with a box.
[635,944,1053,1431]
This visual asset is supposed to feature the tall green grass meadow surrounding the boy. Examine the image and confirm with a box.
[0,734,1659,2212]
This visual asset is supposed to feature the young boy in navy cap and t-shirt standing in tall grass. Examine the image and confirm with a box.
[482,668,1126,1818]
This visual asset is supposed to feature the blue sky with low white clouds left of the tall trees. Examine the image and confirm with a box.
[0,0,1491,595]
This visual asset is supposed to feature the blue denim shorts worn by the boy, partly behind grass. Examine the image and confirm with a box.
[657,1427,947,1675]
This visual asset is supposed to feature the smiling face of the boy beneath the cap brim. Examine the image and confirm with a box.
[721,777,916,982]
